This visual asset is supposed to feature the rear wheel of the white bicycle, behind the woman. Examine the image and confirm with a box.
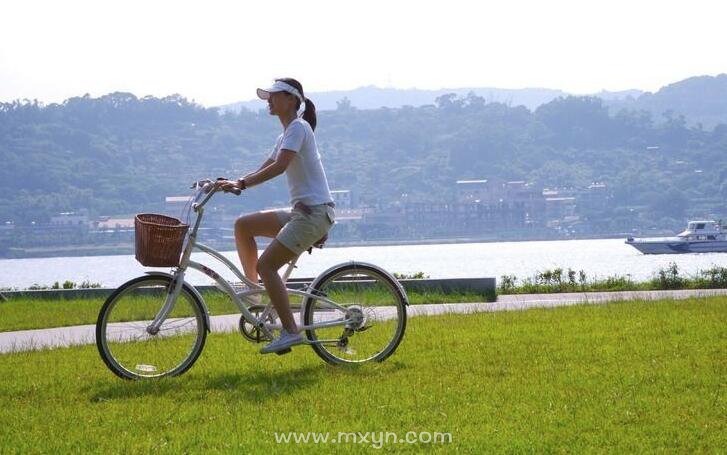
[303,263,406,364]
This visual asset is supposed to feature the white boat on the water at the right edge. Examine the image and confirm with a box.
[626,221,727,254]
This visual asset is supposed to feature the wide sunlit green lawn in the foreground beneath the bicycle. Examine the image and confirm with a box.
[0,297,727,453]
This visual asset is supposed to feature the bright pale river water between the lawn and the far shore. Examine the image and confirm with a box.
[0,239,727,288]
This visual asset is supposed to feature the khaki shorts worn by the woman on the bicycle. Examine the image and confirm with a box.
[275,204,336,255]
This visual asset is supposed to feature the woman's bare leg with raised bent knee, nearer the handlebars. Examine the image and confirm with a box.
[235,212,283,283]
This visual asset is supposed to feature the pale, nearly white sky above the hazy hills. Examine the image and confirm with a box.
[0,0,727,106]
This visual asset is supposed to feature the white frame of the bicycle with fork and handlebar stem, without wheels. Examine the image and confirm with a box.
[147,183,359,343]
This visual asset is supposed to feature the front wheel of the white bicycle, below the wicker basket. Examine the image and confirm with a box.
[96,276,207,379]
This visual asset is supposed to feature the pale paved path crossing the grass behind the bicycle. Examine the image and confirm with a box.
[0,289,727,353]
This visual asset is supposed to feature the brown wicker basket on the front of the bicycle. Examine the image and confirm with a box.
[134,213,189,267]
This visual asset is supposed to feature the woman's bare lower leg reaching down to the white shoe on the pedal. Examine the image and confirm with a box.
[257,239,298,333]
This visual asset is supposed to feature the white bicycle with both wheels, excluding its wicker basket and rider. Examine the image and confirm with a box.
[96,180,409,379]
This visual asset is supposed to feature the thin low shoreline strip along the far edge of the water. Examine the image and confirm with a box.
[0,233,628,260]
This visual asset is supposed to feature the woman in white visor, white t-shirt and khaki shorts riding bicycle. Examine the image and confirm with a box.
[221,78,334,354]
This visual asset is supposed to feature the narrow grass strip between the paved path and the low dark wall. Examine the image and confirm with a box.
[0,292,488,332]
